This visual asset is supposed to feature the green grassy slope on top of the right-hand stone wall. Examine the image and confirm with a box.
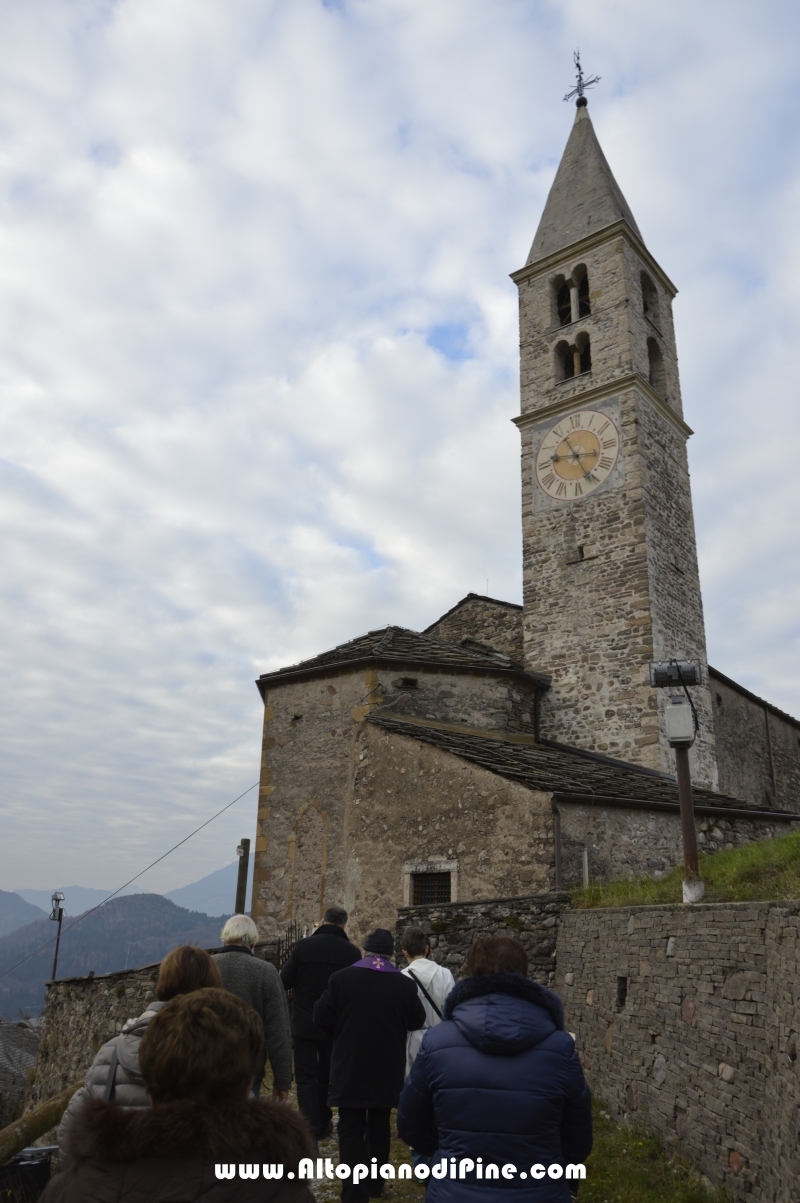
[573,831,800,907]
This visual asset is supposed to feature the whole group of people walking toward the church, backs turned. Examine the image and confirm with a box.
[43,907,592,1203]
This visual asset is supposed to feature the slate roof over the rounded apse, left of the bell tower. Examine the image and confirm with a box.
[256,627,550,694]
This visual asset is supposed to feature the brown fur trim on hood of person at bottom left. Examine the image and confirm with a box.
[66,1098,314,1171]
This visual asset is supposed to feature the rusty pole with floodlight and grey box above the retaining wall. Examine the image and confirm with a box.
[650,660,705,902]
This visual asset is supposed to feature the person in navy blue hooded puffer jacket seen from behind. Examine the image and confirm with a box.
[397,936,592,1203]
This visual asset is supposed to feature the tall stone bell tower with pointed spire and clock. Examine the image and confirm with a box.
[512,95,717,788]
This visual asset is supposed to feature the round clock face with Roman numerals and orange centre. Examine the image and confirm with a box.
[537,409,620,502]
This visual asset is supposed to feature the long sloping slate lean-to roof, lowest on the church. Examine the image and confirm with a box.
[367,710,800,820]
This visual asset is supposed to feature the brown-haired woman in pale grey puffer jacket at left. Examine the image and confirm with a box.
[58,944,221,1156]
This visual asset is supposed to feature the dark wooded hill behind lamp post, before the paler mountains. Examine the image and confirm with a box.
[0,891,227,1019]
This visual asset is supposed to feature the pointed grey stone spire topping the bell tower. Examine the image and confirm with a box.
[526,105,644,266]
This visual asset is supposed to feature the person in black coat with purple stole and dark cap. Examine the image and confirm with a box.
[314,928,426,1203]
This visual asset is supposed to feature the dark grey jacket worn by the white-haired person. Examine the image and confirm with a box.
[214,944,291,1090]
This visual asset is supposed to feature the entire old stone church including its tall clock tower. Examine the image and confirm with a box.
[251,97,800,938]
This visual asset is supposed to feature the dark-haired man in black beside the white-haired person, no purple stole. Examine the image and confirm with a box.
[280,906,361,1140]
